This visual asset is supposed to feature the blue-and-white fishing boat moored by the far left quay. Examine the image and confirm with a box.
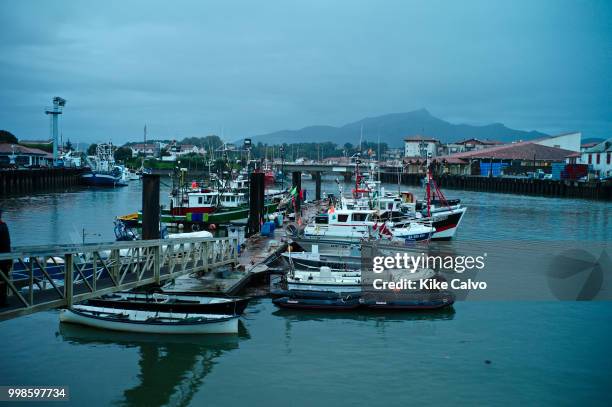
[81,143,127,187]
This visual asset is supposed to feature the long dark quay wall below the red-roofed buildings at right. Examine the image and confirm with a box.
[380,173,612,201]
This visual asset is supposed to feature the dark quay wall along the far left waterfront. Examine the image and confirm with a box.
[0,168,82,195]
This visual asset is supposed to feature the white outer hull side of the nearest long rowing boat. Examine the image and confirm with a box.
[60,309,238,335]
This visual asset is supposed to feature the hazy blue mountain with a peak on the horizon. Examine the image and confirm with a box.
[238,109,546,147]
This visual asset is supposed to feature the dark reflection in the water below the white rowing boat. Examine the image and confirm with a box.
[59,321,250,406]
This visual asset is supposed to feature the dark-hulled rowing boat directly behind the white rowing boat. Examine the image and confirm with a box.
[87,292,249,315]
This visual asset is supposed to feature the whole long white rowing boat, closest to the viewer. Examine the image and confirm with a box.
[60,305,239,334]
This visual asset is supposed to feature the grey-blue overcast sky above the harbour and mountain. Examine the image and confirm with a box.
[0,0,612,143]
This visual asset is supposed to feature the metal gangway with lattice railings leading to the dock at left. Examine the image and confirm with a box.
[0,237,238,321]
